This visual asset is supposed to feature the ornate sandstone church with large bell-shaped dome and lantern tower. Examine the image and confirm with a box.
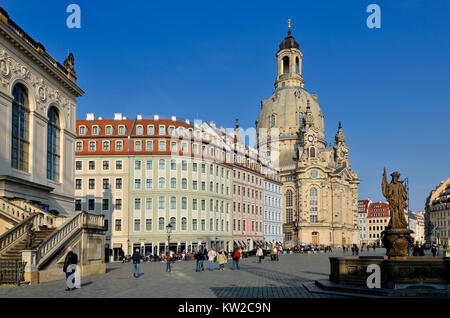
[256,26,360,247]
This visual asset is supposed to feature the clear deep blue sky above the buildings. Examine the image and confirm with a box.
[0,0,450,211]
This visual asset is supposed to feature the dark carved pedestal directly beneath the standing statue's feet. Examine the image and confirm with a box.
[381,228,414,259]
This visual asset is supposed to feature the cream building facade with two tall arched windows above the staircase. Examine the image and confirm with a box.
[0,8,84,215]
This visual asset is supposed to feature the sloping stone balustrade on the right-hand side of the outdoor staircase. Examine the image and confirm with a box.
[36,211,104,265]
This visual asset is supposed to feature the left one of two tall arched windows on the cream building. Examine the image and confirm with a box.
[11,84,30,171]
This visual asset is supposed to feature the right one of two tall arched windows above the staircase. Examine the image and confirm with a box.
[47,107,60,181]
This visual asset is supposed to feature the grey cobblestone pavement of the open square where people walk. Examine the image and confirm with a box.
[0,249,384,298]
